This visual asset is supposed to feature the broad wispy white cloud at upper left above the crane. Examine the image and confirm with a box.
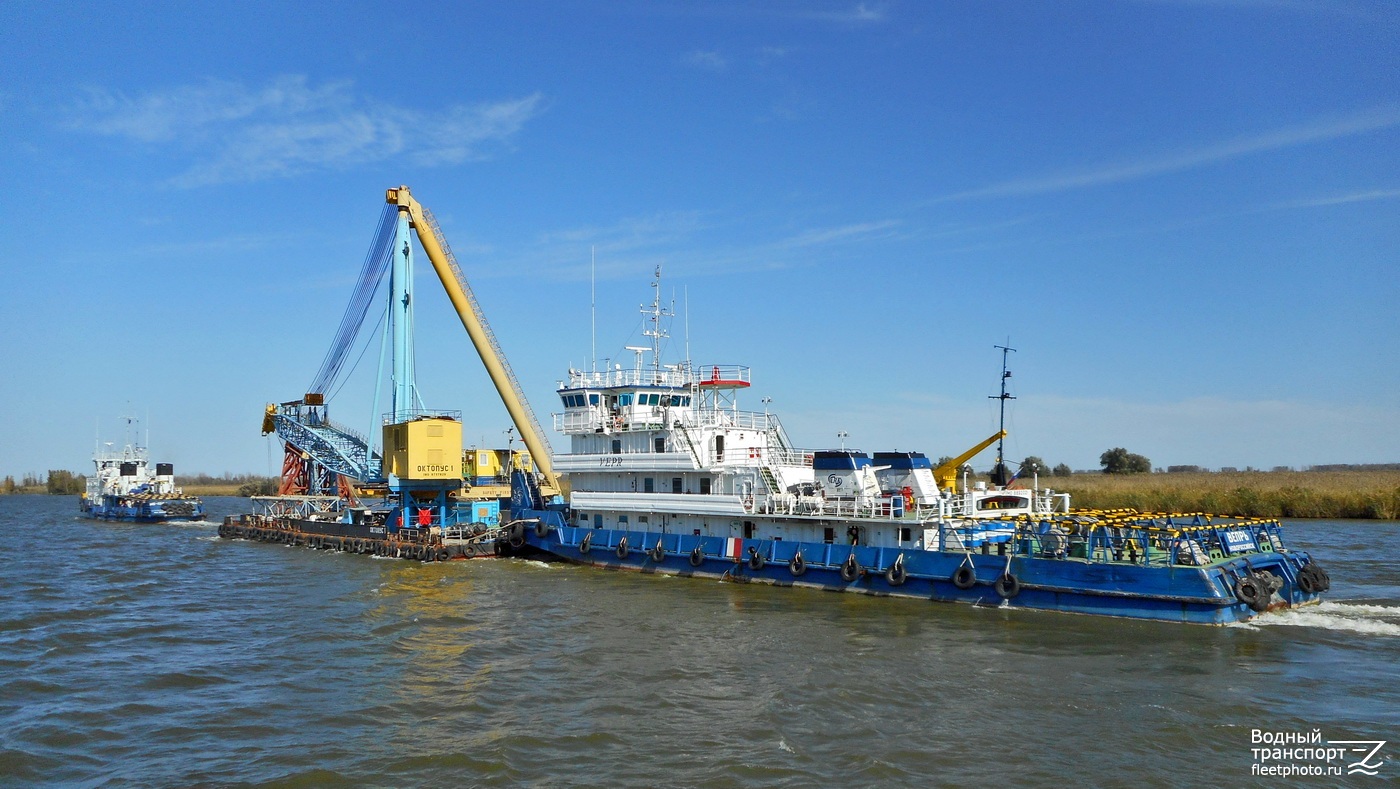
[67,76,543,187]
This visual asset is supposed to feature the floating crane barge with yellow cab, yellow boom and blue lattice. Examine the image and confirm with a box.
[218,186,559,561]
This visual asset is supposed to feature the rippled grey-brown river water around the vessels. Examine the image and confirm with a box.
[0,497,1400,786]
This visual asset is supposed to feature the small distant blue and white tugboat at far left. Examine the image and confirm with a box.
[78,417,204,523]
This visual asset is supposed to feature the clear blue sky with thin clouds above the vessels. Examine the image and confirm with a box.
[0,0,1400,476]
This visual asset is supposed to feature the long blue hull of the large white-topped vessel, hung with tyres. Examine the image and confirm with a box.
[517,520,1319,625]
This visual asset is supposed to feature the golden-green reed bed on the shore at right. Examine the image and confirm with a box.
[1040,471,1400,520]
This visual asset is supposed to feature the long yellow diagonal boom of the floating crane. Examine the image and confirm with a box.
[385,186,559,490]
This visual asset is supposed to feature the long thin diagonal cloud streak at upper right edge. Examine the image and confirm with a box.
[938,105,1400,201]
